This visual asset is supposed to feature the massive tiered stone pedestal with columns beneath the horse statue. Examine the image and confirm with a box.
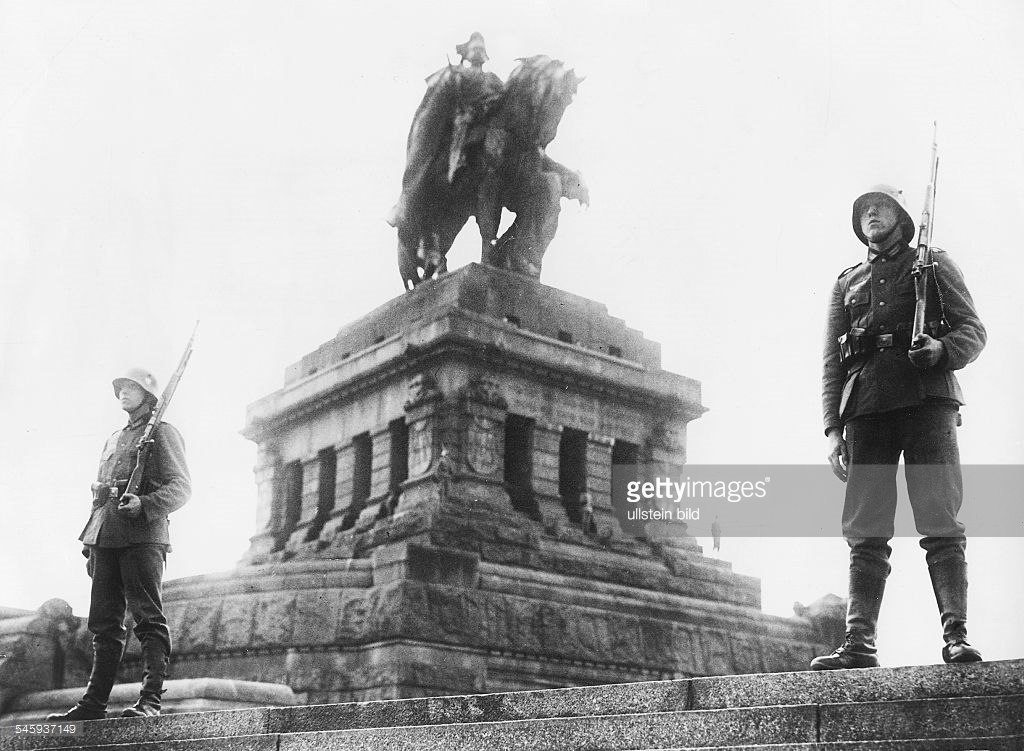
[153,264,830,703]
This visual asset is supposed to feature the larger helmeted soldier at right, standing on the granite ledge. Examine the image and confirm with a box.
[811,185,985,670]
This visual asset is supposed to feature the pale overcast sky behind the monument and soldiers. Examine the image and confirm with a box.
[0,0,1024,665]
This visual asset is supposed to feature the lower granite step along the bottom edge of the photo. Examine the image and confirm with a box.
[5,696,1024,751]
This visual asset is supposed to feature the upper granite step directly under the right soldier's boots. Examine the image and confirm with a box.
[0,661,1024,748]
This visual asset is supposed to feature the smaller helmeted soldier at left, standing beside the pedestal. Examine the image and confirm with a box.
[47,368,191,720]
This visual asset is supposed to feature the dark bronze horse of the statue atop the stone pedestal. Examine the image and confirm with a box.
[388,55,589,289]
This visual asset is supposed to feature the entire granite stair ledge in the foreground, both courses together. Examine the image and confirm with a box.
[0,660,1024,751]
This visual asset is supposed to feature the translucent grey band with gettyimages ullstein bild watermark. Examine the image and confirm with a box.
[611,464,1024,537]
